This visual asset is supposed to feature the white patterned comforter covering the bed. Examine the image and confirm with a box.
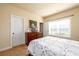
[28,36,79,56]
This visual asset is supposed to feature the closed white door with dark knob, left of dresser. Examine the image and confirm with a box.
[11,16,25,47]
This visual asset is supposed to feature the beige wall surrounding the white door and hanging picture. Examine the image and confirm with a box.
[0,4,43,51]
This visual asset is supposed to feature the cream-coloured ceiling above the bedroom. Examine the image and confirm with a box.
[13,3,79,17]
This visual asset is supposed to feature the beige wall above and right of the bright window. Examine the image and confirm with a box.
[44,6,79,41]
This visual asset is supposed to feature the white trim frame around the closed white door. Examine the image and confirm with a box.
[10,15,25,48]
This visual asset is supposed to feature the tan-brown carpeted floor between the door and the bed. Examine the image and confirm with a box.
[0,45,29,56]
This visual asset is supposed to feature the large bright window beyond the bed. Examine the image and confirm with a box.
[48,17,71,38]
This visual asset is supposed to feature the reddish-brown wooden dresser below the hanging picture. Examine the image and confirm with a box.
[25,32,43,45]
